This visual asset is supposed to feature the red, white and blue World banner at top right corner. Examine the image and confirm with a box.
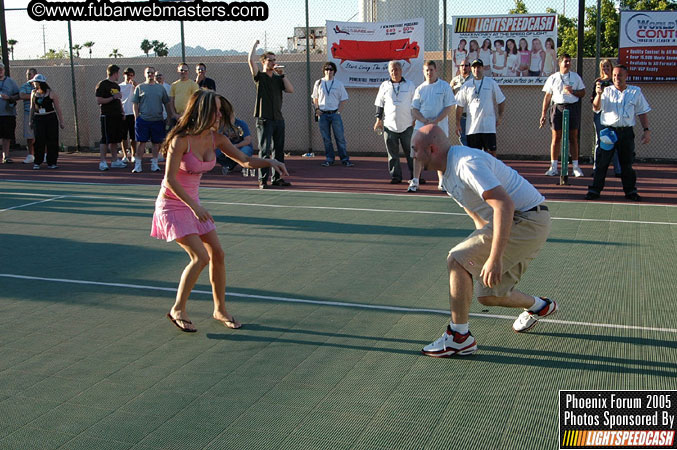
[618,11,677,82]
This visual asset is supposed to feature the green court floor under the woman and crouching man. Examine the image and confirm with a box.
[0,182,677,449]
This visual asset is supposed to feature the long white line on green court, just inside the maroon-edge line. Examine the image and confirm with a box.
[0,192,677,226]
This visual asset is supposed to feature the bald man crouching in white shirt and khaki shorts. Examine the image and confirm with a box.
[413,125,557,357]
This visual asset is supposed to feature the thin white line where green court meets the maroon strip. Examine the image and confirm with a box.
[0,179,677,208]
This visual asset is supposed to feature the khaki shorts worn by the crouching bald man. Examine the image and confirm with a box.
[449,207,550,297]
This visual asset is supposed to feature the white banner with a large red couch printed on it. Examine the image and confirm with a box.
[327,19,424,87]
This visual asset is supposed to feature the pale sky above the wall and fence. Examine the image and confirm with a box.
[5,0,580,59]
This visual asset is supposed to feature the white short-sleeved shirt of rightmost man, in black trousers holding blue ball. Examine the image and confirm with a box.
[600,84,651,127]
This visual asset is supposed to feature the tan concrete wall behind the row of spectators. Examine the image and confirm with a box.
[11,52,677,160]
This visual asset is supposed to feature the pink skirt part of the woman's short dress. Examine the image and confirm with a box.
[150,192,216,242]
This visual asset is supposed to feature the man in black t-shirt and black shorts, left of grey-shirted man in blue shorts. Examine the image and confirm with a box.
[96,64,127,170]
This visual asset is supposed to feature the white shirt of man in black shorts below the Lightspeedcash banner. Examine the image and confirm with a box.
[456,77,505,134]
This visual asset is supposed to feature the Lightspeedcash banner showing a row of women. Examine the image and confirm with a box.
[451,14,559,85]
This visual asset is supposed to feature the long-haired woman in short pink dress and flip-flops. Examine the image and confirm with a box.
[150,89,287,332]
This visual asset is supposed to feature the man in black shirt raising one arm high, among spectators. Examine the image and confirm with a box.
[249,40,294,189]
